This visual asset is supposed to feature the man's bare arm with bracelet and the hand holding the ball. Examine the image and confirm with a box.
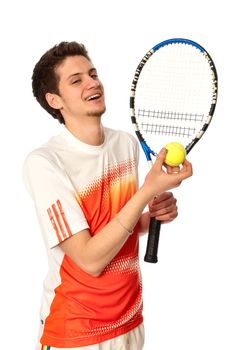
[60,150,192,276]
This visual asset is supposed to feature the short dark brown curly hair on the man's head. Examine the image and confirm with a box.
[32,41,91,124]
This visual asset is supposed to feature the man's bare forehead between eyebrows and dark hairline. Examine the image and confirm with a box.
[56,56,94,79]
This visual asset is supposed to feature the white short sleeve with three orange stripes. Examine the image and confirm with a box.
[23,153,89,248]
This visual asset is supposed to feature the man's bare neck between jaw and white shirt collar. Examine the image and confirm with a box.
[65,117,104,146]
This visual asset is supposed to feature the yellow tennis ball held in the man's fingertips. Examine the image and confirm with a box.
[165,142,186,166]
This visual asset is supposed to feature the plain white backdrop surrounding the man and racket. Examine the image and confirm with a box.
[0,0,232,350]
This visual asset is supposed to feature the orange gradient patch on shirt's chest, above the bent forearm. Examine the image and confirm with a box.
[77,160,137,235]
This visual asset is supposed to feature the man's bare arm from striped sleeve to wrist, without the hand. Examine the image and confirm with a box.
[60,188,154,276]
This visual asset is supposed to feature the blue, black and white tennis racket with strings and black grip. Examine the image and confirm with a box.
[130,39,217,263]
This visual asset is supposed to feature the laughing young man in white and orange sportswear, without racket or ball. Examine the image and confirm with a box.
[24,42,192,350]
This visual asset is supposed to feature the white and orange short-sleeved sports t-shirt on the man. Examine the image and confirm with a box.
[24,128,143,348]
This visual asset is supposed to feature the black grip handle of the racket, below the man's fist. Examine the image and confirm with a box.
[144,218,161,263]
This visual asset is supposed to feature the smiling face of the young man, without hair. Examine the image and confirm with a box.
[52,56,105,119]
